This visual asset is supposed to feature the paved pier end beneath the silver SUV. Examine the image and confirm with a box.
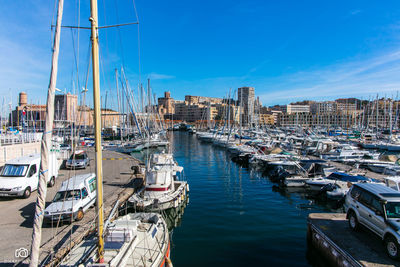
[308,213,400,267]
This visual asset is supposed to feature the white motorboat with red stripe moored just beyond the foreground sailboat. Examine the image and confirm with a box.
[128,153,189,211]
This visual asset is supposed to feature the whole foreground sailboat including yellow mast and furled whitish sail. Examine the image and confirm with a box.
[30,0,170,267]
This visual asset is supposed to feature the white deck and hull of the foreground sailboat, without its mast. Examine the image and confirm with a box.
[60,213,170,267]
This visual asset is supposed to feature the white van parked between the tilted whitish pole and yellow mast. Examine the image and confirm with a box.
[44,173,96,222]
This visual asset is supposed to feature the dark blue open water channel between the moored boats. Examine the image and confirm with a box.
[166,132,340,266]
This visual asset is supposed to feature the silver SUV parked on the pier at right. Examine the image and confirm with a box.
[344,183,400,259]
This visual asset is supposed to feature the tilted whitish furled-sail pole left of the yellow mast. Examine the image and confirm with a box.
[29,0,64,267]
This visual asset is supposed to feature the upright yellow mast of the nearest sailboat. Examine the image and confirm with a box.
[89,0,104,263]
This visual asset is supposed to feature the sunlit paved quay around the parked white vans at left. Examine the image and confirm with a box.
[0,150,143,266]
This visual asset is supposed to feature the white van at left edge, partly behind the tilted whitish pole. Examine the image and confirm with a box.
[0,152,58,198]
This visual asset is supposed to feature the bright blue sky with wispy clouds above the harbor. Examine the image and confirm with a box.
[0,0,400,113]
